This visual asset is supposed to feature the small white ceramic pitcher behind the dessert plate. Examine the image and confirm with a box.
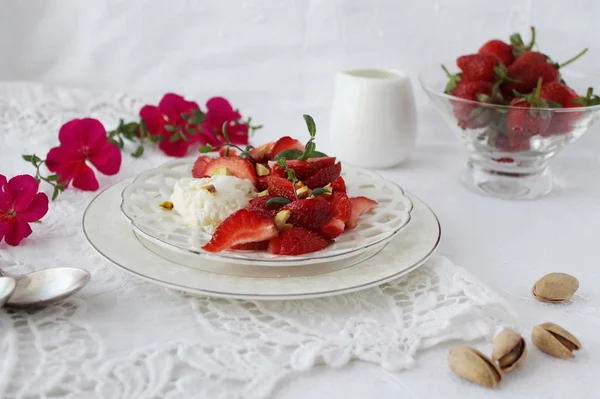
[330,69,417,169]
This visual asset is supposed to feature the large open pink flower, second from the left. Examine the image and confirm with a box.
[46,118,121,191]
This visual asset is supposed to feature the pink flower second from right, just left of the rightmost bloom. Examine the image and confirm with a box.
[140,93,200,157]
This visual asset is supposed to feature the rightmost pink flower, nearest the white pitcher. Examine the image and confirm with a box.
[202,97,248,146]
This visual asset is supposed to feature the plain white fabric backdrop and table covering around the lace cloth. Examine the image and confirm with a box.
[0,0,600,399]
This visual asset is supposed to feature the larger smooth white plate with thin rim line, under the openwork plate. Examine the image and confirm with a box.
[83,181,441,300]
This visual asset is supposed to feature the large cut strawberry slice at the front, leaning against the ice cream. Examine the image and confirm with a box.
[202,209,279,252]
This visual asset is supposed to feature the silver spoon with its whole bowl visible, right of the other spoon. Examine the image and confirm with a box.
[0,267,90,309]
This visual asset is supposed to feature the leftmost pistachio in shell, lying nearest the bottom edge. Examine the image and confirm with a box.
[448,346,502,388]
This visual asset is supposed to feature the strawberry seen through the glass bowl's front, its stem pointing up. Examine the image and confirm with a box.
[506,78,551,149]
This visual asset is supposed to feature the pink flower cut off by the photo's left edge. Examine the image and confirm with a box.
[0,175,48,246]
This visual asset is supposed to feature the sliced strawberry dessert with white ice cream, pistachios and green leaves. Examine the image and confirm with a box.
[171,115,377,255]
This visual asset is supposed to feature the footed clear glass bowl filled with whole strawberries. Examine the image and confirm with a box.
[419,28,600,199]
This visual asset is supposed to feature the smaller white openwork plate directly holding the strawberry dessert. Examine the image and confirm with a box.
[121,159,412,267]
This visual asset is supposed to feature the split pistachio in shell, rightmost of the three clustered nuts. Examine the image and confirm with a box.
[531,323,581,359]
